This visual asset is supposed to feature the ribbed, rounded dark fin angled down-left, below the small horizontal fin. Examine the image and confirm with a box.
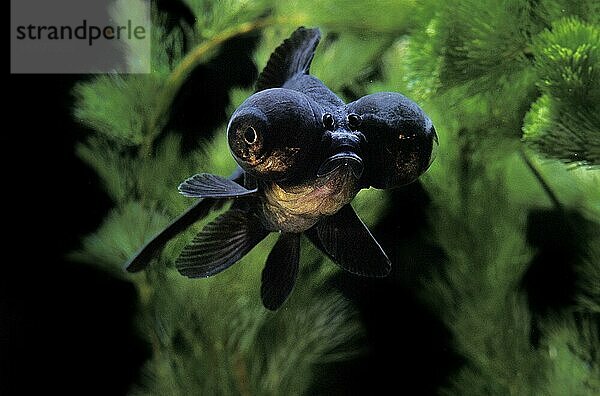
[175,209,268,278]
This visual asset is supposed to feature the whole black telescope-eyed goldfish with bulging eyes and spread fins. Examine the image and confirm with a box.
[126,27,439,310]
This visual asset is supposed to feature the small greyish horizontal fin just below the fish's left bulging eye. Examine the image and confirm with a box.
[178,173,257,198]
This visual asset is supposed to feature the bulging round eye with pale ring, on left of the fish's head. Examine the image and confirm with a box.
[227,88,321,181]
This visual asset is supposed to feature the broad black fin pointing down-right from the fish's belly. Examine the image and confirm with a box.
[306,204,392,277]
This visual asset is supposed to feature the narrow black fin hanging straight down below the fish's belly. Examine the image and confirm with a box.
[260,233,300,311]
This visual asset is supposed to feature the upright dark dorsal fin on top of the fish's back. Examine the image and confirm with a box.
[256,27,321,92]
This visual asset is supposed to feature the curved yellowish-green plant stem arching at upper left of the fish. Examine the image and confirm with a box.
[140,17,300,157]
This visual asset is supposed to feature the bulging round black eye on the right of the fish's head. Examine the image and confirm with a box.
[346,92,439,188]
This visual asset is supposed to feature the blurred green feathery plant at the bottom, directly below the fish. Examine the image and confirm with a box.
[131,258,360,395]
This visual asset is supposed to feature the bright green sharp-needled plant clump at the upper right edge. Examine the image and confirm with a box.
[523,18,600,165]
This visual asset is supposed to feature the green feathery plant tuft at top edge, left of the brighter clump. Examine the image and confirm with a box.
[436,0,539,92]
